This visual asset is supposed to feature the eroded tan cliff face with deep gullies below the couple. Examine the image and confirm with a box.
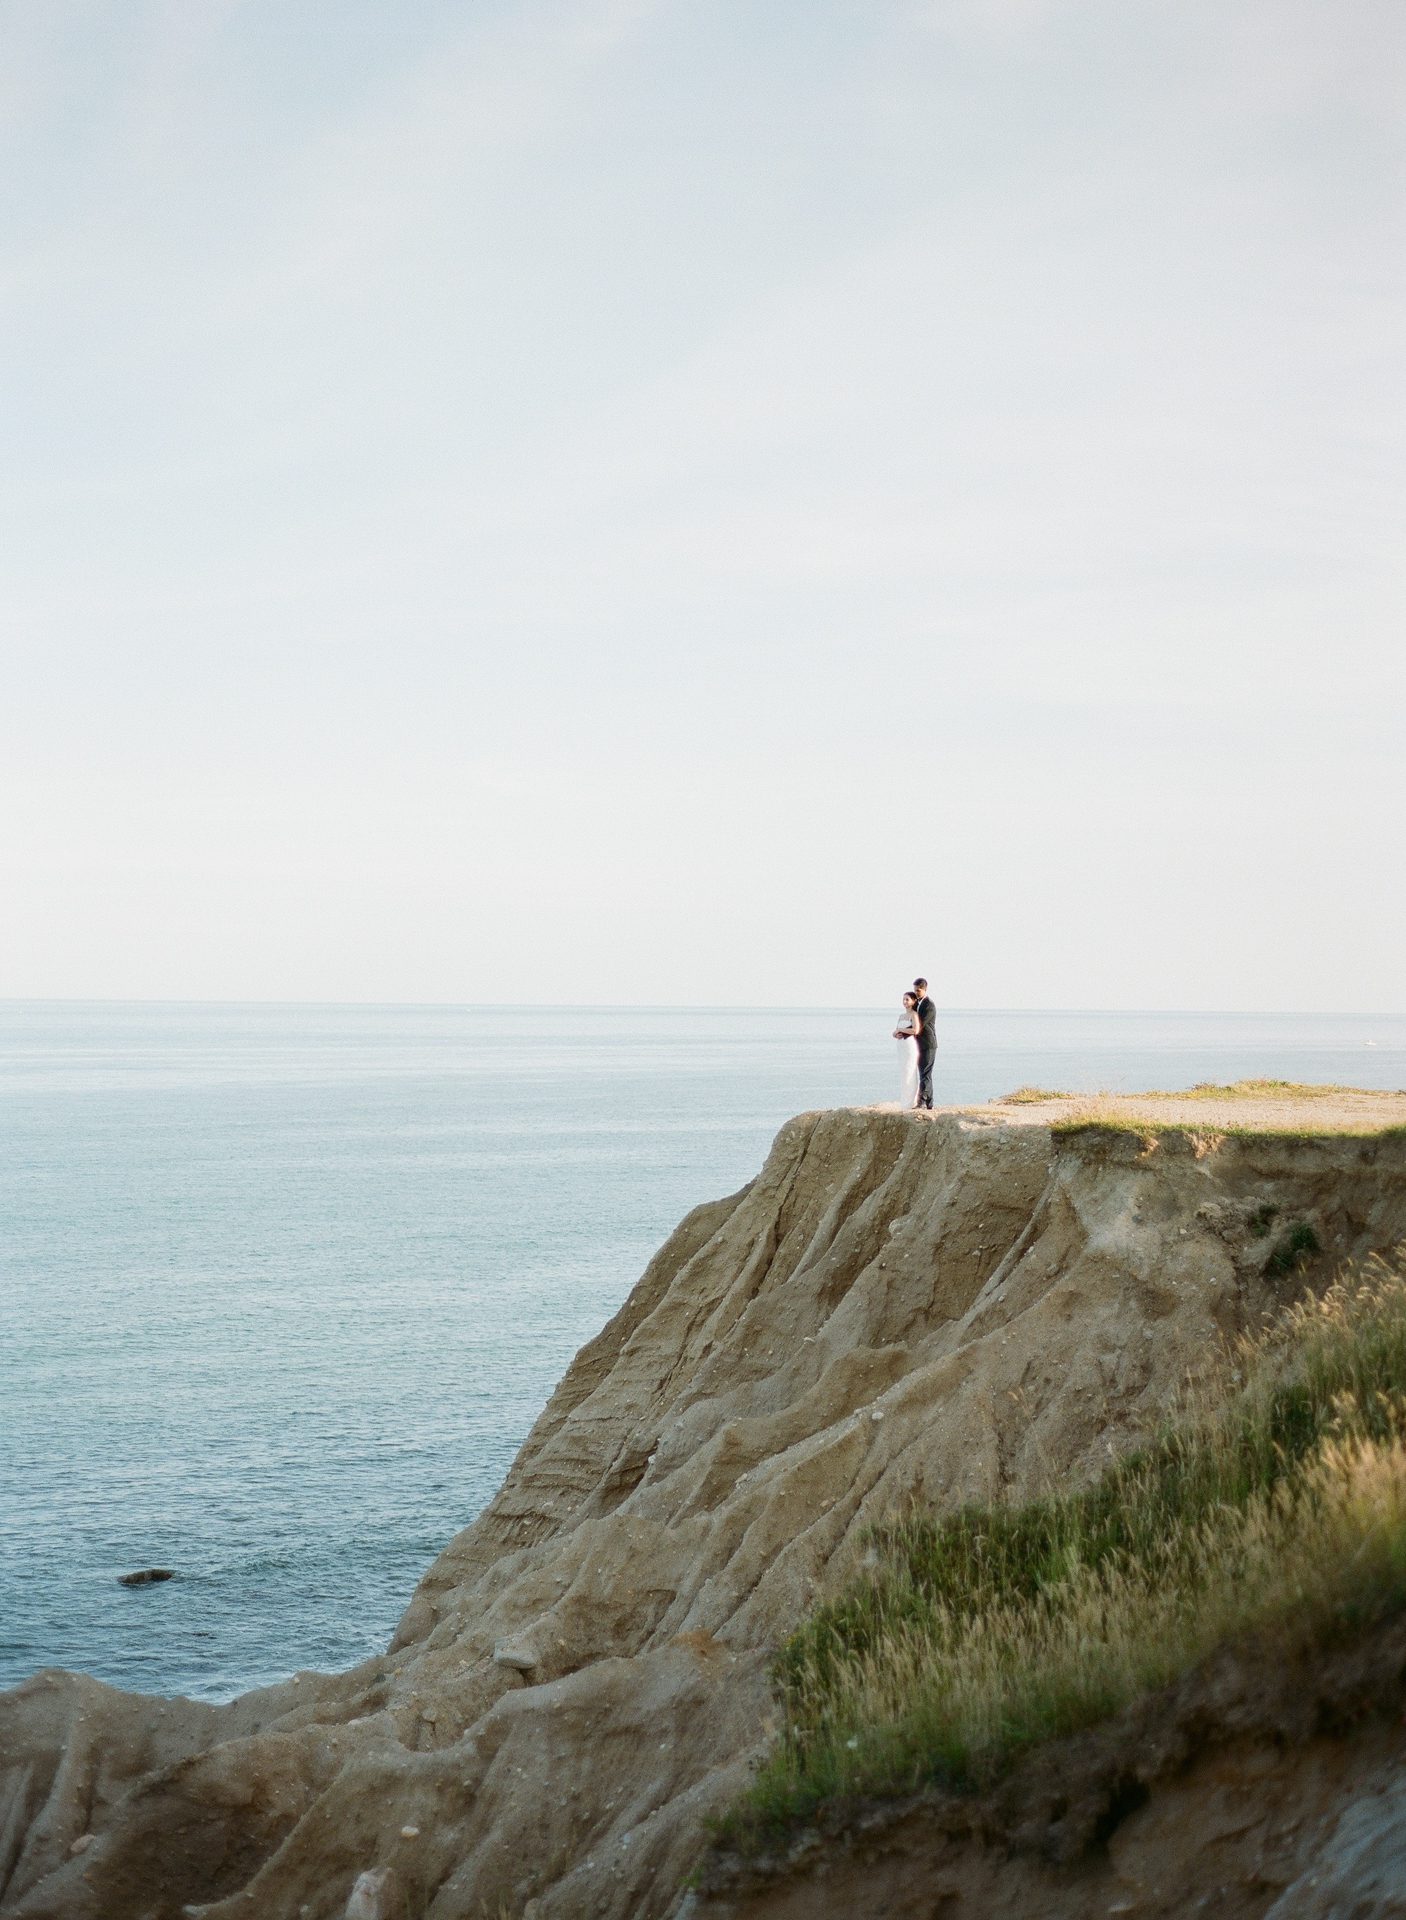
[0,1110,1406,1920]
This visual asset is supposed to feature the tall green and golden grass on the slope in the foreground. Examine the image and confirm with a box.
[718,1265,1406,1851]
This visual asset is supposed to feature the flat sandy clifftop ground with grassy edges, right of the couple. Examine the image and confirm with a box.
[910,1081,1406,1133]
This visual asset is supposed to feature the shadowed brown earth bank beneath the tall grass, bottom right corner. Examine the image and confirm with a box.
[688,1615,1406,1920]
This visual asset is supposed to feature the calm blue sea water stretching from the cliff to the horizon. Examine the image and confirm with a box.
[0,1002,1406,1699]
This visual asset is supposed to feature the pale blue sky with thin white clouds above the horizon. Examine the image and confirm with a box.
[0,0,1406,1012]
